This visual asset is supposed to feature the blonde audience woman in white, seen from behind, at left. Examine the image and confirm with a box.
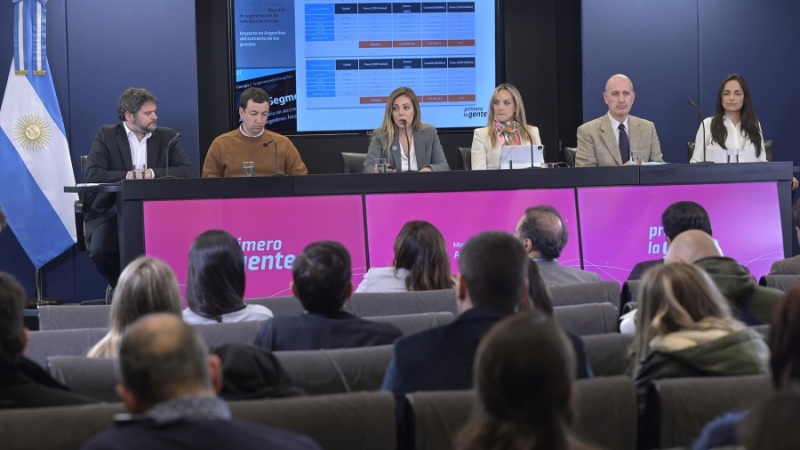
[87,256,181,358]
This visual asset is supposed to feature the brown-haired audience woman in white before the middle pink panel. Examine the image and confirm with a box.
[356,220,453,292]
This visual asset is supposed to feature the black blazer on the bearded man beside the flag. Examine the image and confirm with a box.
[84,123,195,234]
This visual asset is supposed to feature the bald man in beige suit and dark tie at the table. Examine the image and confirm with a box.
[575,74,663,167]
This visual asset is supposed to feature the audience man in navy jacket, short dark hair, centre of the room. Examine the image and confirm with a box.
[383,231,528,416]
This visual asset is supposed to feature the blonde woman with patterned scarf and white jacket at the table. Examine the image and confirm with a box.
[472,83,542,170]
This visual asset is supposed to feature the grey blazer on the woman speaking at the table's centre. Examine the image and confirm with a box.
[364,125,450,173]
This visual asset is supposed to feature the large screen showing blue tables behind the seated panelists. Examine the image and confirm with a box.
[232,0,497,133]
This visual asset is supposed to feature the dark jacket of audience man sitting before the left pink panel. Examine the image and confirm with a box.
[255,311,403,351]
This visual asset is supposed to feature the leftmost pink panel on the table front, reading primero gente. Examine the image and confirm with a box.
[144,195,367,298]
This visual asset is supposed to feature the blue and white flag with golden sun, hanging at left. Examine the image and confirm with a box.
[0,0,78,269]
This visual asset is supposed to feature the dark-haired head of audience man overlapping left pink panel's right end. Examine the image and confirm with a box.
[292,241,353,314]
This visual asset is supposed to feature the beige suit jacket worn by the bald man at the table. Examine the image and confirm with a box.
[575,114,663,167]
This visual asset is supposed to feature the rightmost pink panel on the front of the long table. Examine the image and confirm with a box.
[578,183,783,283]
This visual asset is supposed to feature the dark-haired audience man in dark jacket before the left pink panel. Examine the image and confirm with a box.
[255,241,402,351]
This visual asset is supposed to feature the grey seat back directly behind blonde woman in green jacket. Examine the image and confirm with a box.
[639,375,772,448]
